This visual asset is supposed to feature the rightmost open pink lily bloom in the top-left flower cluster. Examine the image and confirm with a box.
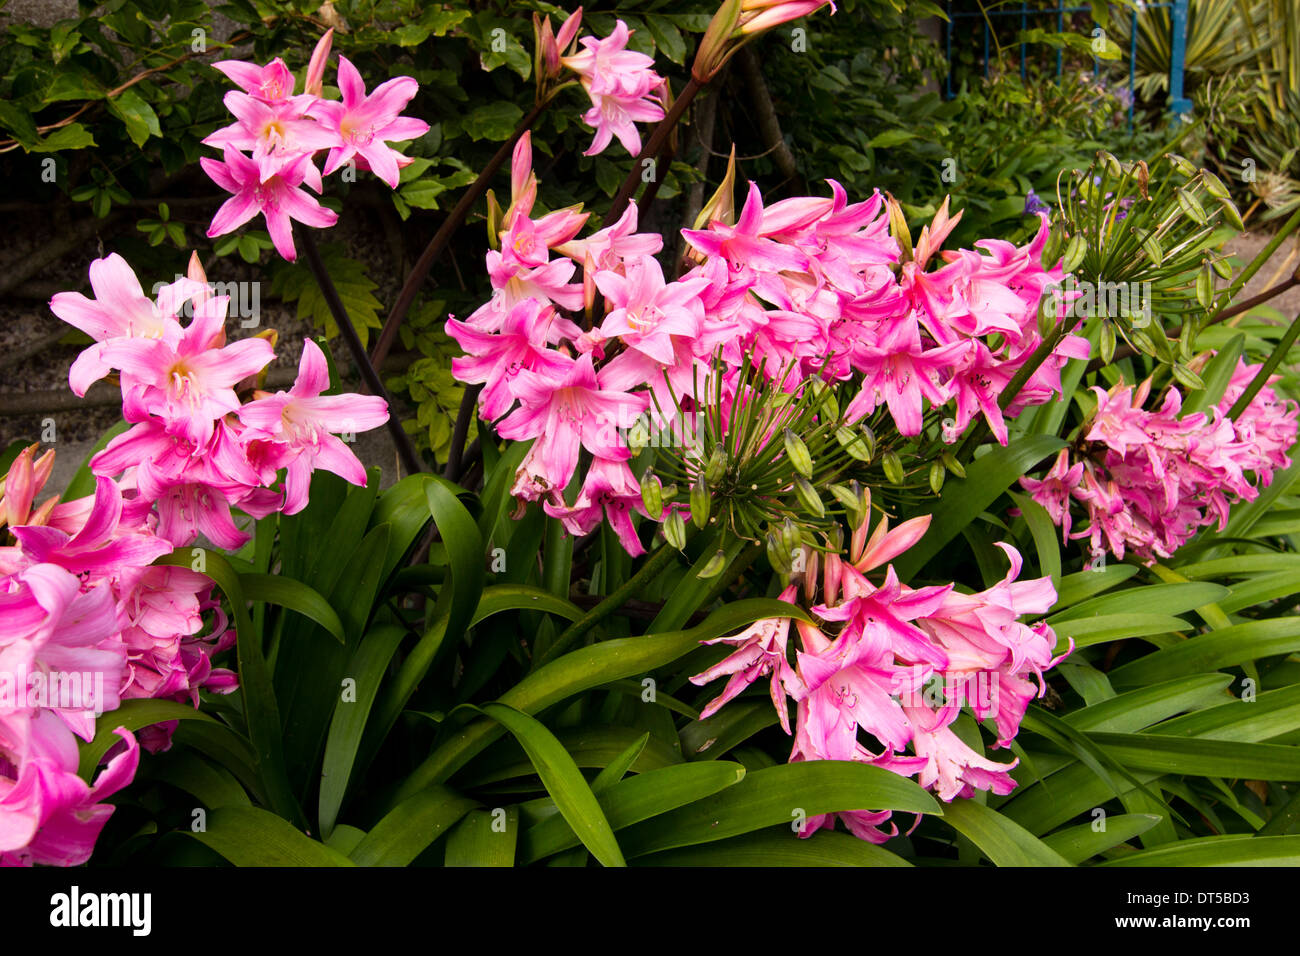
[313,56,429,189]
